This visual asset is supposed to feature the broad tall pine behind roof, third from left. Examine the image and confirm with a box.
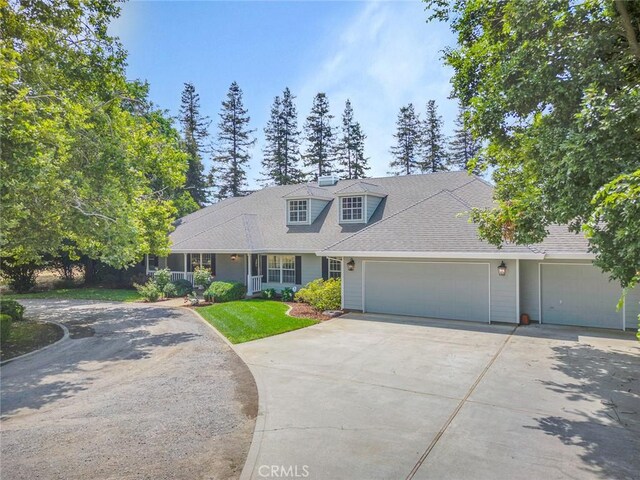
[262,88,302,185]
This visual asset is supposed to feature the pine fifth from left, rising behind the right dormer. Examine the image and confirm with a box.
[336,100,369,179]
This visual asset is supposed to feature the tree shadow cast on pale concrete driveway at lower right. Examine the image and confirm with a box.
[526,344,640,479]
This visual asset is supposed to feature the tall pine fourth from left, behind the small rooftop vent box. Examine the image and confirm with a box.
[304,93,334,179]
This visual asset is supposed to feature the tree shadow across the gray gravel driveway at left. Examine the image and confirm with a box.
[0,302,201,419]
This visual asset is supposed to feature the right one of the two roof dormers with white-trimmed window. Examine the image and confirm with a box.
[335,181,387,224]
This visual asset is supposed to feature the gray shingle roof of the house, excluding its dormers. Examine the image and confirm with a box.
[170,172,586,255]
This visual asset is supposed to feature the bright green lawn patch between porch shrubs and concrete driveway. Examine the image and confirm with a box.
[197,299,318,343]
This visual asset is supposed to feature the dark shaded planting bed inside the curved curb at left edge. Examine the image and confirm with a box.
[0,321,63,360]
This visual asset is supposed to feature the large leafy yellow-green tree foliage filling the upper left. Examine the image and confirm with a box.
[0,0,187,268]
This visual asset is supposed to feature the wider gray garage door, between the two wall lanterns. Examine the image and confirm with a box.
[364,261,489,322]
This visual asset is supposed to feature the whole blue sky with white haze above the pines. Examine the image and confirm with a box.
[111,1,457,187]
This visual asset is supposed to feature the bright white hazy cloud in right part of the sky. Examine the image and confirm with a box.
[293,2,456,176]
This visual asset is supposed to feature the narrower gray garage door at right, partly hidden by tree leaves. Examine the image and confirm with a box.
[540,263,622,328]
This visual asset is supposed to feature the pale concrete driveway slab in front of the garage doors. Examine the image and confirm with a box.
[237,314,640,480]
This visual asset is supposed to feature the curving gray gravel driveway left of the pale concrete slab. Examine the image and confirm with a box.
[0,300,257,480]
